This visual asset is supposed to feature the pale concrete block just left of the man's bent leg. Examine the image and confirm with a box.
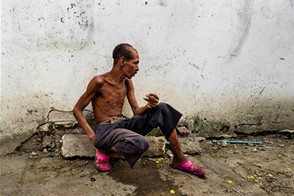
[61,134,95,158]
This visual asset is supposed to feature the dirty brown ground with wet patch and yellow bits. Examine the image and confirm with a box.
[0,134,294,196]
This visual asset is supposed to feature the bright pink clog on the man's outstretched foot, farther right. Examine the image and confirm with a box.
[170,160,205,178]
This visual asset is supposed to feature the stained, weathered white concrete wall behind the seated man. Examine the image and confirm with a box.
[0,0,294,153]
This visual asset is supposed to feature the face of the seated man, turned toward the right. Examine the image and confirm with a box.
[123,49,139,79]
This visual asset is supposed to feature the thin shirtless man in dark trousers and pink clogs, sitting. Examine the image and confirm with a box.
[73,44,205,177]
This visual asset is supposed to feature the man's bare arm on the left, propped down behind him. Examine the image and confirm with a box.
[73,76,104,142]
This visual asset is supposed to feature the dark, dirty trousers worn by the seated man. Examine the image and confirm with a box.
[94,103,182,167]
